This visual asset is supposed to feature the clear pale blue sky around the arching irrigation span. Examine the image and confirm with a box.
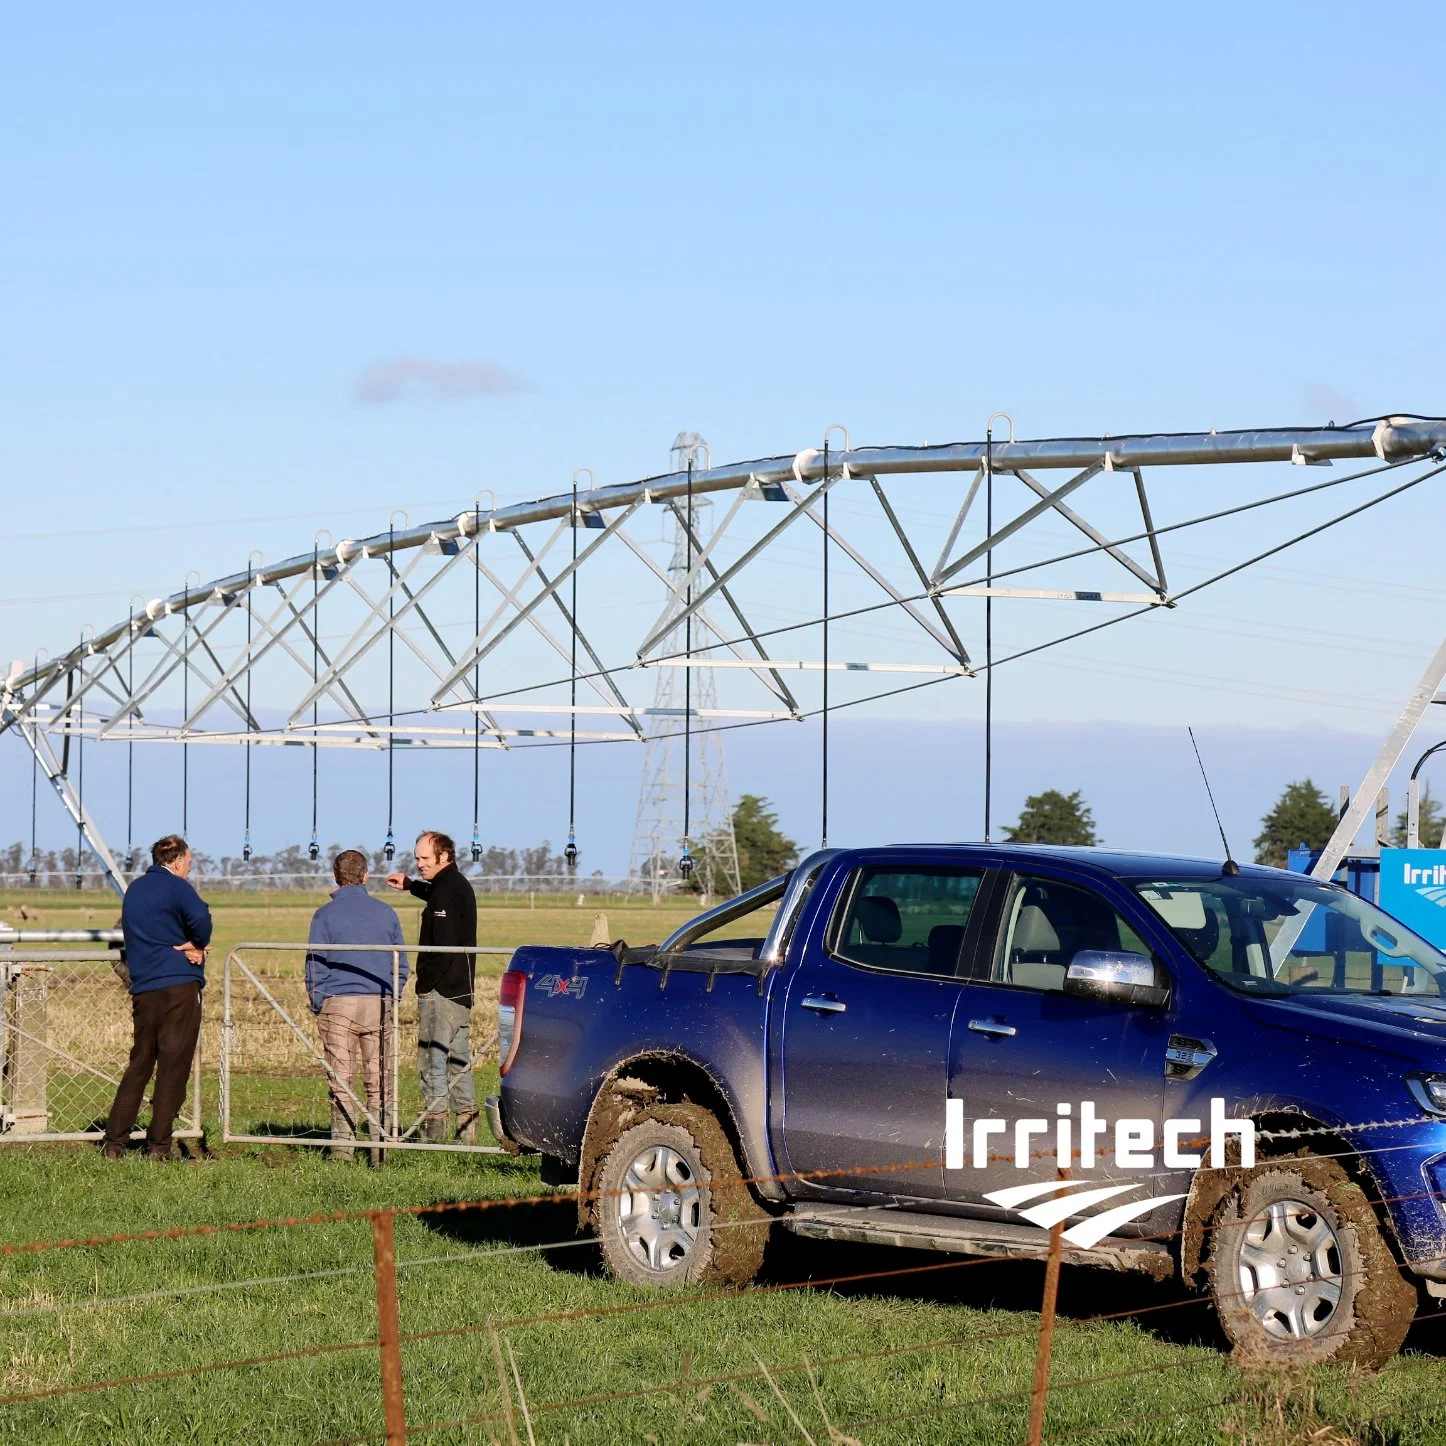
[0,4,1446,856]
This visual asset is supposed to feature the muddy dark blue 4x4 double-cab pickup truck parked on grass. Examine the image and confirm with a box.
[487,844,1446,1366]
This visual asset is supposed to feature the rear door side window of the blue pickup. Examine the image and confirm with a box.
[833,866,983,976]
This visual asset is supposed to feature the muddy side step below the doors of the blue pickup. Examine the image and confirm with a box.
[778,1203,1174,1280]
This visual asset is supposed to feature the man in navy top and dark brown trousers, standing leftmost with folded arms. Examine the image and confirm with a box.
[103,833,211,1160]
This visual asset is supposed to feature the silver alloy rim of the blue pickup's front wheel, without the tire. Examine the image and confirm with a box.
[1241,1200,1340,1340]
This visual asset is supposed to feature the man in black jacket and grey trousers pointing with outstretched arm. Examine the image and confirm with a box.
[386,830,477,1145]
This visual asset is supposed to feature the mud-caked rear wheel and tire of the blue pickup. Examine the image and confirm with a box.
[594,1105,769,1290]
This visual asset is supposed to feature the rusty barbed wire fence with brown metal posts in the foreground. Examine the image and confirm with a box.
[0,1121,1446,1446]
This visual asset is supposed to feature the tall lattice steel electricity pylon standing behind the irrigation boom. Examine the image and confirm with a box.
[628,432,740,904]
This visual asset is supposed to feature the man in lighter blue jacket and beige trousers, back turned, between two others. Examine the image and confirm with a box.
[307,849,406,1161]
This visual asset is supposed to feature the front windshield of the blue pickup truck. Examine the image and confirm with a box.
[1134,876,1446,999]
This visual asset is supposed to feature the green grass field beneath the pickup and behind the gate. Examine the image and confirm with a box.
[0,897,1446,1446]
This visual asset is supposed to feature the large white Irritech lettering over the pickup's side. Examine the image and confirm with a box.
[944,1099,1255,1170]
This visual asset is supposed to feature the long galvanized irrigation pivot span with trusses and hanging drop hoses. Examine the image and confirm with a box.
[0,414,1446,889]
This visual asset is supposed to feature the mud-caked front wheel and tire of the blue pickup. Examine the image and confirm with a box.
[1206,1155,1416,1369]
